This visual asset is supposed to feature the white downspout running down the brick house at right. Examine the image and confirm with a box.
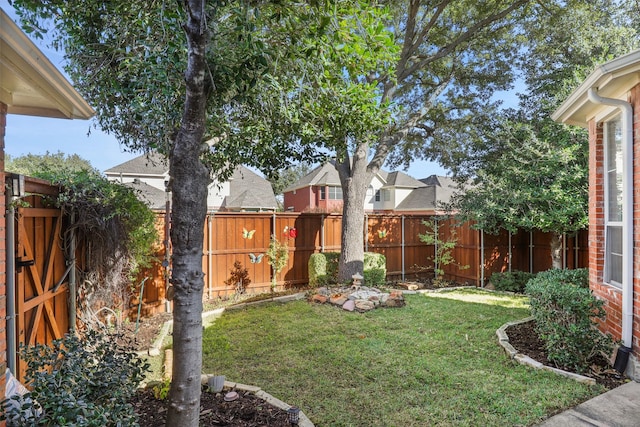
[588,88,633,357]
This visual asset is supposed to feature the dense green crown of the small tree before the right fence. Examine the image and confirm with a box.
[453,119,588,233]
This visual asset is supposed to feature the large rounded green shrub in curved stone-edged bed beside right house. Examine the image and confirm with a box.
[526,269,613,372]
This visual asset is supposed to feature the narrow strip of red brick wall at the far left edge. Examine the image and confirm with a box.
[0,103,7,412]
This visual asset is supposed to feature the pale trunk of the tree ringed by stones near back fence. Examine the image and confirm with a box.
[336,144,370,282]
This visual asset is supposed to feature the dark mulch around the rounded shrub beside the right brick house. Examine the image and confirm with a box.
[506,321,628,390]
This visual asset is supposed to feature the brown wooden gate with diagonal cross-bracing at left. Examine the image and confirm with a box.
[15,192,69,377]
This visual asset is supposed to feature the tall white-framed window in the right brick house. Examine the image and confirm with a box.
[604,117,623,287]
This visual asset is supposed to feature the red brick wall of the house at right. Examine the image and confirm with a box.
[589,85,640,364]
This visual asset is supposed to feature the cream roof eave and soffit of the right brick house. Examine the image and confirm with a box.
[551,50,640,127]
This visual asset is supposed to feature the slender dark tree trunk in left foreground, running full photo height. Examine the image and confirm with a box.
[166,0,210,427]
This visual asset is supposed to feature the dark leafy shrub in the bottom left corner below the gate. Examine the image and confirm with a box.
[0,331,148,426]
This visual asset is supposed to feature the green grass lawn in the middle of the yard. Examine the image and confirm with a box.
[203,290,603,426]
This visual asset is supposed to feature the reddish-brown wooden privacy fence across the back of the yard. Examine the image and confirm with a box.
[142,212,588,311]
